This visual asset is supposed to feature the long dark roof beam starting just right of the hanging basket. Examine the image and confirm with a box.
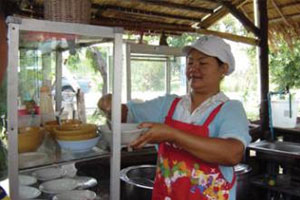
[92,4,202,22]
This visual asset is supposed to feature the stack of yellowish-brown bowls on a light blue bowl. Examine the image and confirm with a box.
[54,124,100,152]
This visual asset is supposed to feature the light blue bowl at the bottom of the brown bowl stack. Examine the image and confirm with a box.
[57,136,100,153]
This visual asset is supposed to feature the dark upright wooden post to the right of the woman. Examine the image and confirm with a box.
[256,0,269,137]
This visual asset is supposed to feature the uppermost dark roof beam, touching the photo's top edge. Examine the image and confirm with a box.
[138,0,214,13]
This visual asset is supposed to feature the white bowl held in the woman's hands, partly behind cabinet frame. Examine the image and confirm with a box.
[99,123,147,146]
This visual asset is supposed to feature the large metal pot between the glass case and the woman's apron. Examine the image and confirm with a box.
[120,165,156,200]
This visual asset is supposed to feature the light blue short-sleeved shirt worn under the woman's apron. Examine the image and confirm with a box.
[127,95,251,200]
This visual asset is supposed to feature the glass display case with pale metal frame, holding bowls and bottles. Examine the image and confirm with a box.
[7,17,123,200]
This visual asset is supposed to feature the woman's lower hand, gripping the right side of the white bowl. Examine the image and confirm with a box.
[129,122,176,149]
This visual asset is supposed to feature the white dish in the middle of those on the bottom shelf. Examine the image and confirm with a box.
[39,178,78,194]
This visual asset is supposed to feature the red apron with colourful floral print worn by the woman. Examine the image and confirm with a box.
[152,98,236,200]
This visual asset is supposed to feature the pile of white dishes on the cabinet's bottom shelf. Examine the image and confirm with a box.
[28,167,97,200]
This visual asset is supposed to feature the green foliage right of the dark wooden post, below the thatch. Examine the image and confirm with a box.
[269,40,300,90]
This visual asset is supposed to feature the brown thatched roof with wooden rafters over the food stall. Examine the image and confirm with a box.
[4,0,300,43]
